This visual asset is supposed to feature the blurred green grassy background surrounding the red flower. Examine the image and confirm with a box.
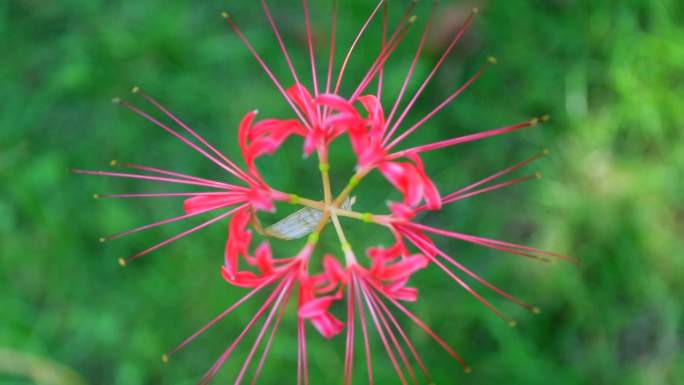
[0,0,684,384]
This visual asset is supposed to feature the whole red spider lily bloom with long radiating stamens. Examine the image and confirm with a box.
[71,0,577,384]
